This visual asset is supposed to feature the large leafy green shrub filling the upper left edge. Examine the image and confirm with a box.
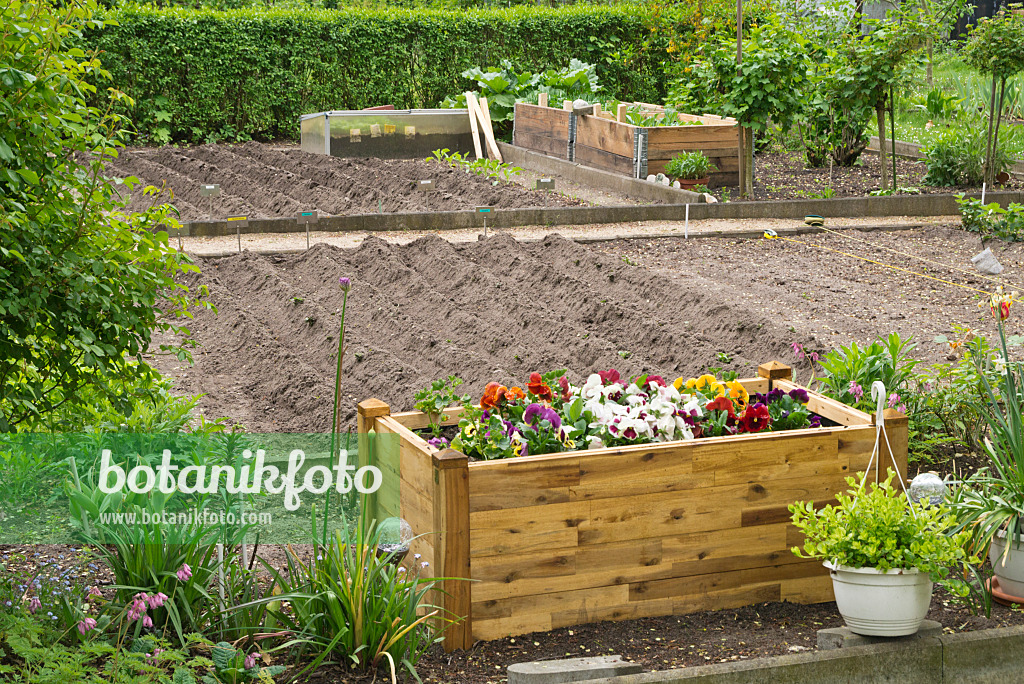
[0,0,207,432]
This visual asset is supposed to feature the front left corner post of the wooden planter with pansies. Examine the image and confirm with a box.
[433,448,473,651]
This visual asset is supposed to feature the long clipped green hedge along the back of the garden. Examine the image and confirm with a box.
[87,5,666,140]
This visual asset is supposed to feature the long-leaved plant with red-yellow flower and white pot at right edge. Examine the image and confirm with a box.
[950,287,1024,602]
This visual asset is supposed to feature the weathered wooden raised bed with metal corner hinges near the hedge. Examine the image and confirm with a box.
[512,102,739,187]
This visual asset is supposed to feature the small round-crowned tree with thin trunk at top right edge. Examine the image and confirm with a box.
[964,10,1024,185]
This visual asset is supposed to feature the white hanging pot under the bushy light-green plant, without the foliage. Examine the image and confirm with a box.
[824,562,932,637]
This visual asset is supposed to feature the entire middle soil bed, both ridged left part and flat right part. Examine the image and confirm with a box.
[158,227,1024,432]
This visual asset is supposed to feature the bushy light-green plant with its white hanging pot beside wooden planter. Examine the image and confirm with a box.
[790,470,977,637]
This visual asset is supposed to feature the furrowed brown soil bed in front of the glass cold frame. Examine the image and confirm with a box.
[108,142,582,221]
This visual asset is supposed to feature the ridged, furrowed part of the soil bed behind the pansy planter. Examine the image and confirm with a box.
[173,236,793,432]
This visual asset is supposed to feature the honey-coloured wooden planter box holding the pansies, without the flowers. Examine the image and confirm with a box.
[358,362,907,650]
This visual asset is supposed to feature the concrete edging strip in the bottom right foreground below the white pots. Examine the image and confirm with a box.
[569,627,1024,684]
